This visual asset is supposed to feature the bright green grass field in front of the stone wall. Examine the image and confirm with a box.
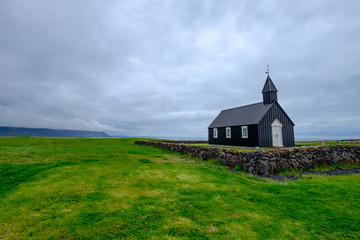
[0,137,360,239]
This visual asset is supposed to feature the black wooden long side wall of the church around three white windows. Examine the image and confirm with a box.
[208,125,259,147]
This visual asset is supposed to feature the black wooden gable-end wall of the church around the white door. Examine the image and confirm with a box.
[258,102,295,147]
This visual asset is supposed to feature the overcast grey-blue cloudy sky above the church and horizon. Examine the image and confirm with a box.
[0,0,360,140]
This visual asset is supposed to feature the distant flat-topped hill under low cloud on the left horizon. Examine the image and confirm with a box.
[0,127,110,137]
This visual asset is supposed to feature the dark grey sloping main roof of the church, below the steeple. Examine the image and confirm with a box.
[209,101,276,128]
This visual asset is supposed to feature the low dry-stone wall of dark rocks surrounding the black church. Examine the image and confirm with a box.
[135,141,360,176]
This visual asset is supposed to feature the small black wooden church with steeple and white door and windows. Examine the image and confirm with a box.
[208,74,295,147]
